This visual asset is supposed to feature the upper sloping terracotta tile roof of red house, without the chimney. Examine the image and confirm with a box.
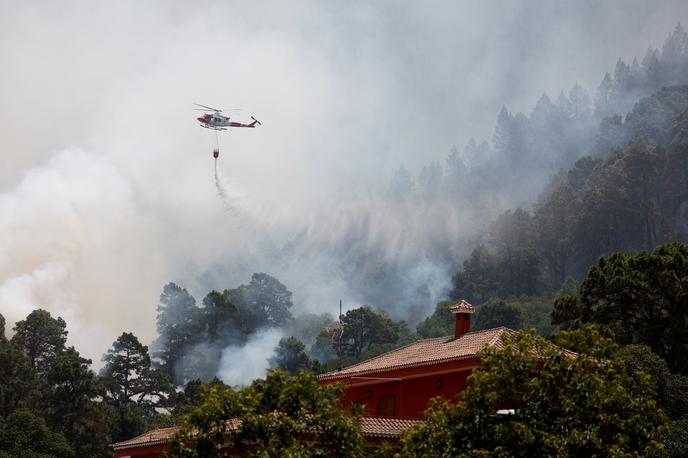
[318,327,515,381]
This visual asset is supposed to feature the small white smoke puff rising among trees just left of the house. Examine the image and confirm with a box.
[217,328,283,386]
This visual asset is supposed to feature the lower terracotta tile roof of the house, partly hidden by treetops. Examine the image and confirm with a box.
[110,417,422,450]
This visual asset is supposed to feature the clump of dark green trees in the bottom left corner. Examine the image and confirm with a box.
[0,311,111,457]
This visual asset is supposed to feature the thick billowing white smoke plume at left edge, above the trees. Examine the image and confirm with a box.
[0,148,165,360]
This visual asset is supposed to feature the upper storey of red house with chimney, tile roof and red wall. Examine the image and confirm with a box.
[318,300,514,419]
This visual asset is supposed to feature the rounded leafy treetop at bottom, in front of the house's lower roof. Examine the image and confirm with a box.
[172,370,365,458]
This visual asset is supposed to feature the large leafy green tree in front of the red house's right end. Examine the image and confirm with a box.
[402,328,667,457]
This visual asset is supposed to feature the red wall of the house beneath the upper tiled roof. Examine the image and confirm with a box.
[326,359,476,418]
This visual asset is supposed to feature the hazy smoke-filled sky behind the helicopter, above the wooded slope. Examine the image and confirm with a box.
[0,0,688,360]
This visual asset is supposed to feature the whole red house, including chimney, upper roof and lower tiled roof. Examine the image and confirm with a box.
[112,301,514,458]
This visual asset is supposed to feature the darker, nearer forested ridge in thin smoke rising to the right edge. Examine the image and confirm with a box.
[452,86,688,303]
